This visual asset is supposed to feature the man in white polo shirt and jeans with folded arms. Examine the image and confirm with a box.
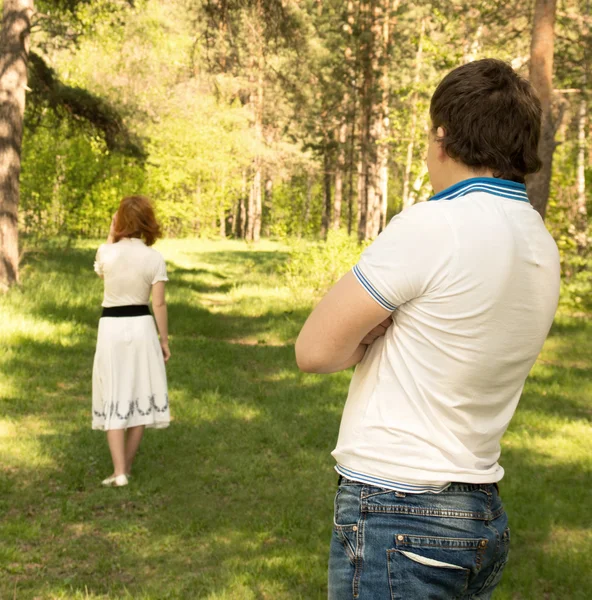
[296,59,560,600]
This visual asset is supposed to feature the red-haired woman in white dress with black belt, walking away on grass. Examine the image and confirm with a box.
[92,196,171,487]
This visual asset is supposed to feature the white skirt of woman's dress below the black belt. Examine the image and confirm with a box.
[92,315,171,430]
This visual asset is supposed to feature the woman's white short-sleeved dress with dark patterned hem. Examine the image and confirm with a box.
[92,238,170,430]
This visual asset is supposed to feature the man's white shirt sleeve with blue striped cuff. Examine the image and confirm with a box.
[353,202,455,312]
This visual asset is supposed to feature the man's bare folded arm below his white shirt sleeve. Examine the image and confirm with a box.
[296,271,392,373]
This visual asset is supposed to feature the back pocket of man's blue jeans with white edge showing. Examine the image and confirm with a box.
[387,534,487,600]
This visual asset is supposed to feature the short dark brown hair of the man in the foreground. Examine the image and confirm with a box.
[430,58,542,183]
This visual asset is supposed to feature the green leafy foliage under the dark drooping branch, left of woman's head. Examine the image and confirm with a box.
[20,111,144,238]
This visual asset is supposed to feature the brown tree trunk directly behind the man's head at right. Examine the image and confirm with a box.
[528,0,558,219]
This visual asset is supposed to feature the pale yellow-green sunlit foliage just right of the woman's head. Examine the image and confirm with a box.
[146,89,254,236]
